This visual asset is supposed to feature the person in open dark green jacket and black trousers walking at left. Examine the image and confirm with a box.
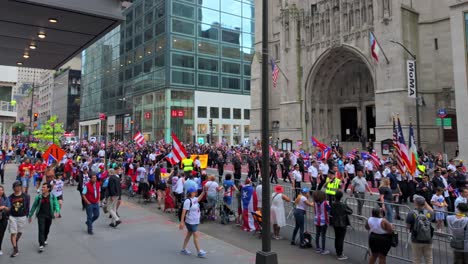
[28,183,60,252]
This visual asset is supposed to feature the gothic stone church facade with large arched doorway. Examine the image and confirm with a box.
[250,0,457,156]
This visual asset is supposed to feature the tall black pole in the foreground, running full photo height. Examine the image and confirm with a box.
[255,0,278,264]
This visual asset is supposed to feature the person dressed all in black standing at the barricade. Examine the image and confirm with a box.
[330,191,353,260]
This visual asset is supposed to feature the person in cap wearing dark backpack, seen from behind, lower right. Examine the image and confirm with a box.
[406,194,434,264]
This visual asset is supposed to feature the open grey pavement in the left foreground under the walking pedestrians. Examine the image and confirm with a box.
[0,165,255,264]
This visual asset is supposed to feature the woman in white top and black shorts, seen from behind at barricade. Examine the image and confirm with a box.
[366,208,393,264]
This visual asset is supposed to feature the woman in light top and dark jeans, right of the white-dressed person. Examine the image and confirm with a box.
[291,188,315,248]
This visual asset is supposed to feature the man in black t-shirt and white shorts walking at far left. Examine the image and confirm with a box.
[8,181,30,258]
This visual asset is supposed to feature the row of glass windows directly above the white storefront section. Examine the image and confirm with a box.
[171,70,250,91]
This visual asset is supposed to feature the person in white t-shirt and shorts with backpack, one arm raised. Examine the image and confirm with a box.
[179,187,206,258]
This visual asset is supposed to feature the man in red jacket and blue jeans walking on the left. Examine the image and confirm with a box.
[81,174,101,235]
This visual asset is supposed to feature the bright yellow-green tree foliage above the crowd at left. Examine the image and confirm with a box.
[33,116,65,151]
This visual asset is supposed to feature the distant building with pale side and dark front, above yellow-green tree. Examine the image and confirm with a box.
[52,69,81,134]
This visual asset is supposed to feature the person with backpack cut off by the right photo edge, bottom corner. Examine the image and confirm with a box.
[447,203,468,264]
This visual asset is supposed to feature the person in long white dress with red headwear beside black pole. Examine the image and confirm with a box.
[270,185,291,240]
